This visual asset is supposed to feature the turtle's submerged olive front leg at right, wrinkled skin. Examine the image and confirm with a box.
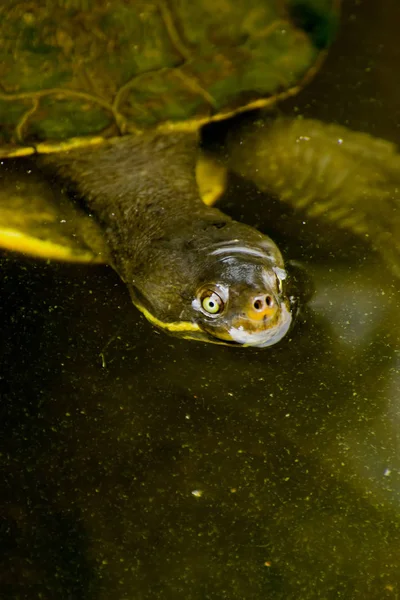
[228,119,400,277]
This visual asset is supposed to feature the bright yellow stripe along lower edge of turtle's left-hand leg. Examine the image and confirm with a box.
[0,229,105,263]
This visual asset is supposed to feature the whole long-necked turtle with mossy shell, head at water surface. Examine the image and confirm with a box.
[0,0,400,348]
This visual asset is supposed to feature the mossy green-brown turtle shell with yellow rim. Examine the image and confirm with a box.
[0,0,338,156]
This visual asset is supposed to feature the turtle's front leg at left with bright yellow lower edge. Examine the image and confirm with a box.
[0,159,109,263]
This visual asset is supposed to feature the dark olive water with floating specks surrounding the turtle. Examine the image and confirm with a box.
[0,0,400,600]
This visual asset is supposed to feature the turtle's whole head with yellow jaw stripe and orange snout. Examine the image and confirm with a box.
[131,221,297,348]
